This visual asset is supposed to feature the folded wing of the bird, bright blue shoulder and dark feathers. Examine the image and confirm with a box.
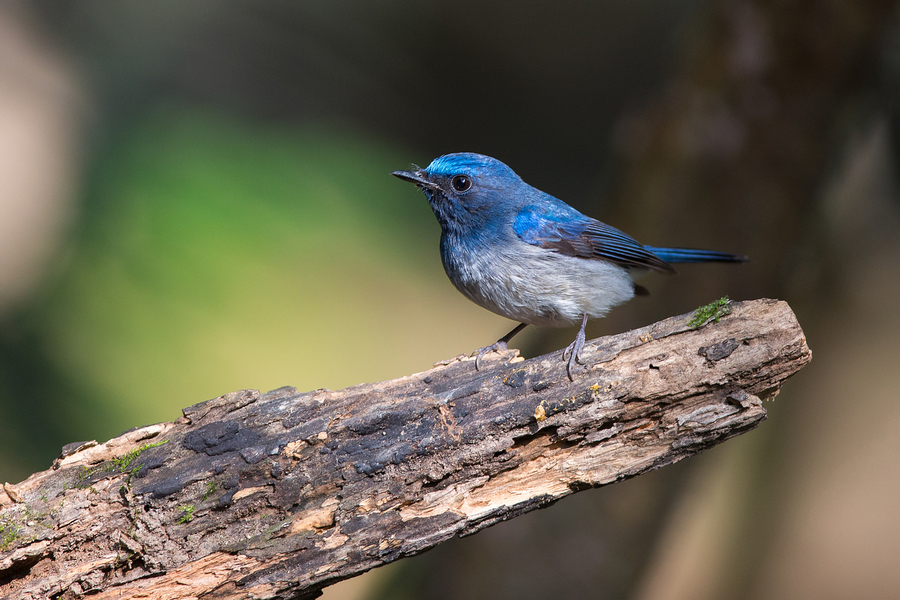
[513,205,675,273]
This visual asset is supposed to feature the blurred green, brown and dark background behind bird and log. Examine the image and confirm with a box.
[0,0,900,600]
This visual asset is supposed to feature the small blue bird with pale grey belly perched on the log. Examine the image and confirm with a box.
[391,152,747,379]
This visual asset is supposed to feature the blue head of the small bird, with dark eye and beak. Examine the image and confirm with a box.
[391,152,531,234]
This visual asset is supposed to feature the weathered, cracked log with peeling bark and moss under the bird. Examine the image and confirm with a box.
[0,300,811,598]
